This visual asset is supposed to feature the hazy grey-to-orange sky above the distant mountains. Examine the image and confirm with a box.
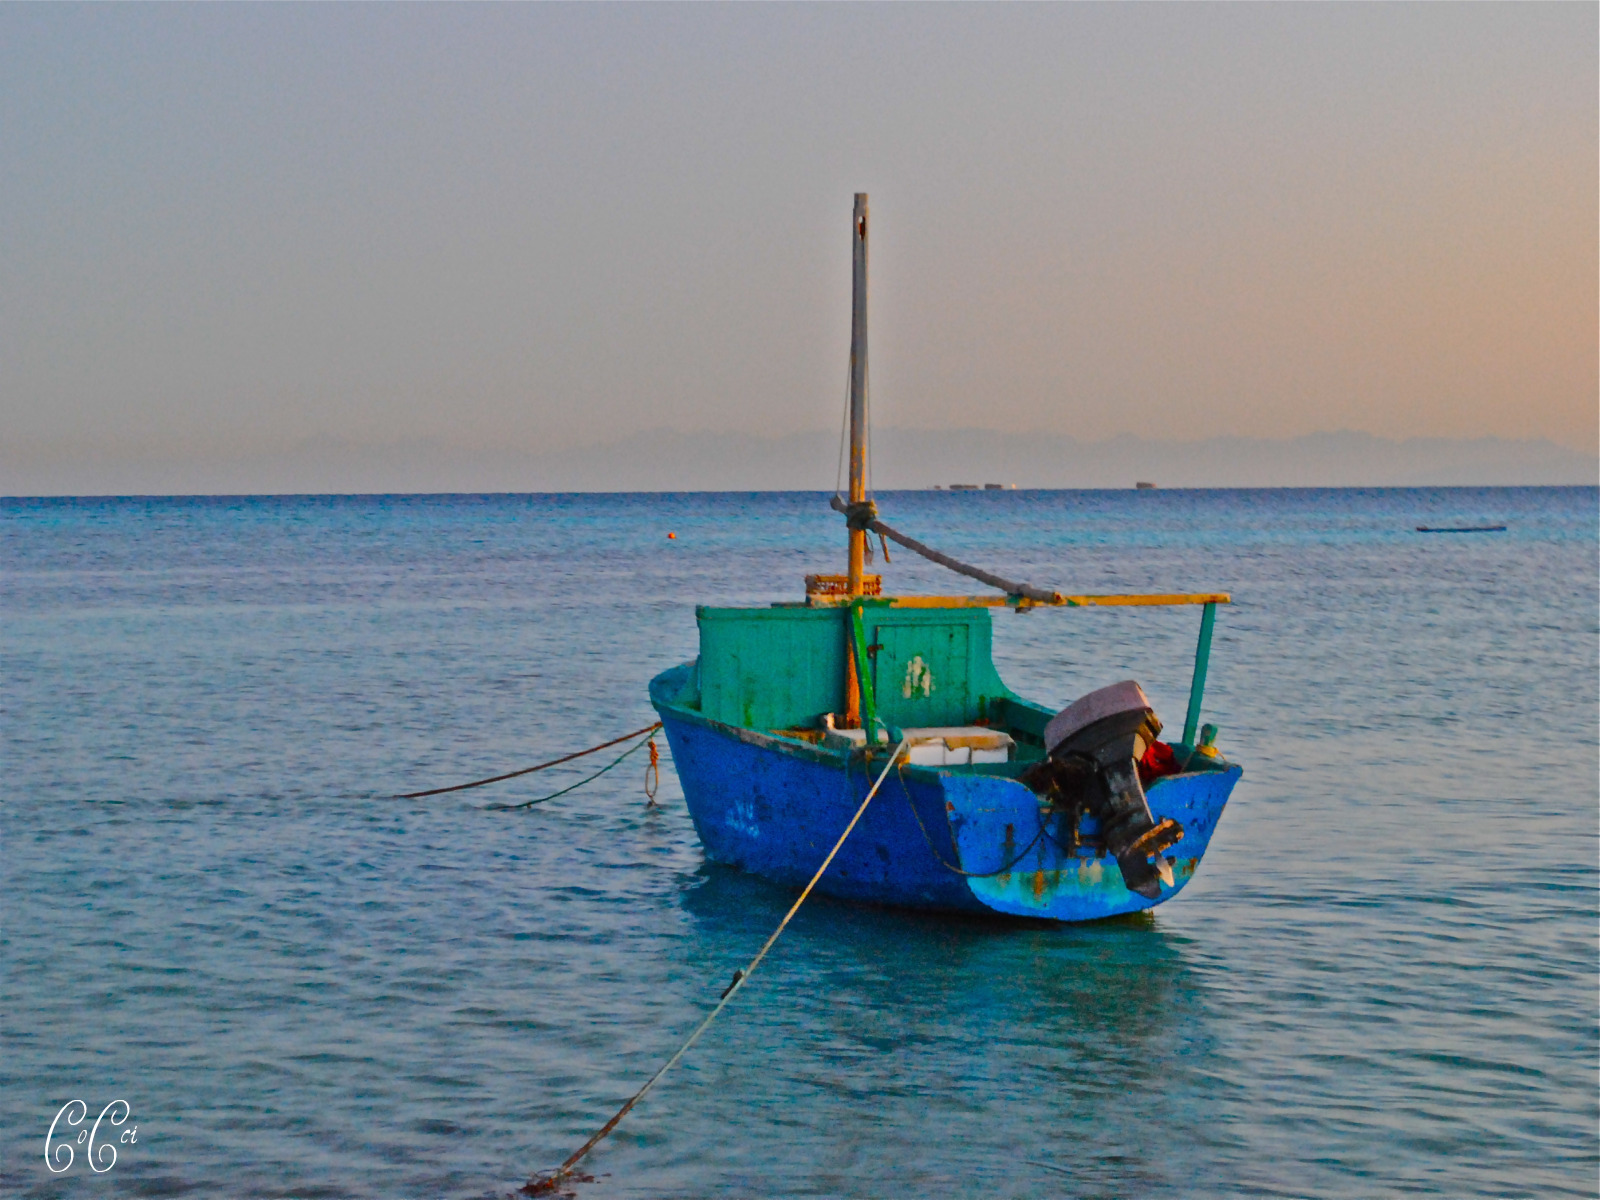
[0,3,1600,464]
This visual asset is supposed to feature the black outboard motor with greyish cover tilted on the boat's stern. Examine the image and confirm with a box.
[1022,680,1184,899]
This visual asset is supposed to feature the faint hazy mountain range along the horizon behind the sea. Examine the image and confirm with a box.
[0,429,1600,496]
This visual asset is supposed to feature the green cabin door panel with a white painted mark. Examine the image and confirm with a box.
[867,624,971,728]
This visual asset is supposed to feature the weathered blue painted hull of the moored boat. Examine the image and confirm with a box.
[650,667,1242,922]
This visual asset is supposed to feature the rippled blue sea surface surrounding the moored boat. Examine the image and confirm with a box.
[0,488,1600,1198]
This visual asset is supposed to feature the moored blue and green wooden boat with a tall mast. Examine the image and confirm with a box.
[650,202,1242,922]
